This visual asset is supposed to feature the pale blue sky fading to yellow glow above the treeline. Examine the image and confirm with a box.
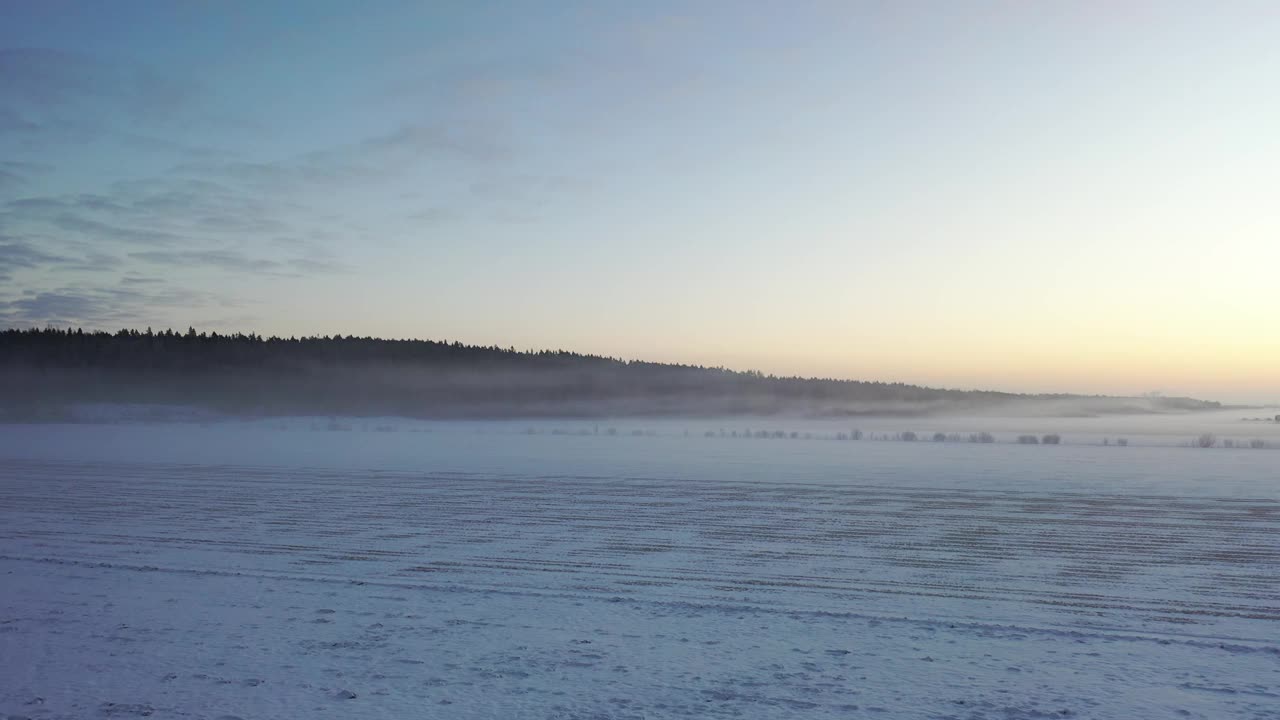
[0,0,1280,402]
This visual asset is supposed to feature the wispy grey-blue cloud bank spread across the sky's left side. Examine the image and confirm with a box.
[0,26,586,323]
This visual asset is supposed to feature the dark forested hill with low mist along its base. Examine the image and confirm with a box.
[0,328,1221,418]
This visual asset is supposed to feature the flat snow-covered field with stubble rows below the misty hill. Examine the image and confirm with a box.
[0,418,1280,719]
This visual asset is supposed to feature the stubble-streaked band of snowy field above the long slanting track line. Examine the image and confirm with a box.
[0,462,1280,641]
